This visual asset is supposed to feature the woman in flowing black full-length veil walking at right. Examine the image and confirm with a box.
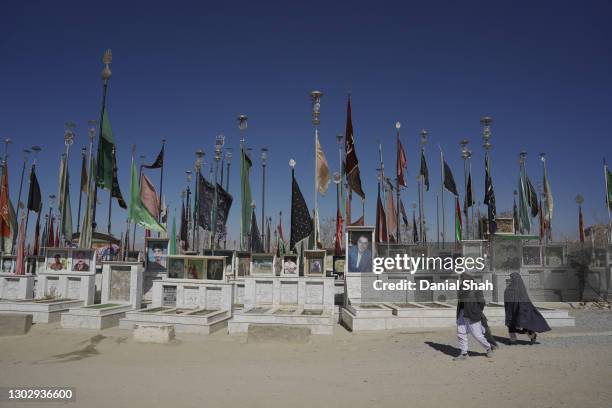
[504,272,550,344]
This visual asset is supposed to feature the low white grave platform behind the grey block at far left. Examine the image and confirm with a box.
[0,299,83,323]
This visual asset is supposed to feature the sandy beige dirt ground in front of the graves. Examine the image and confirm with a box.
[0,318,612,408]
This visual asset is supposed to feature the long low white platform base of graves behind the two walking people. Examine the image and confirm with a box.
[341,302,575,332]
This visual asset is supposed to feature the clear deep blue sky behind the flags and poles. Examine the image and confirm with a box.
[0,1,612,245]
